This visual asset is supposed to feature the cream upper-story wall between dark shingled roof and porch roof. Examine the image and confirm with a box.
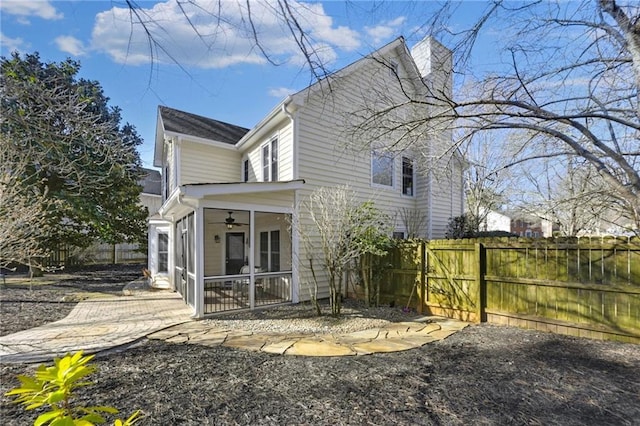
[180,139,242,185]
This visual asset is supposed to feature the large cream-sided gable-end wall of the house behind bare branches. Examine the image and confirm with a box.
[296,40,463,300]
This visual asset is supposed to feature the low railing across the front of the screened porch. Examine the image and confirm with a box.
[204,271,291,315]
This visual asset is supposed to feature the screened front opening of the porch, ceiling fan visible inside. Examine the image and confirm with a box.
[204,208,292,315]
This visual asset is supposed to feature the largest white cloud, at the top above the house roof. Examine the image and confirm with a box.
[91,0,360,68]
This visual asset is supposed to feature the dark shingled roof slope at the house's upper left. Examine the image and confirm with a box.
[158,106,249,145]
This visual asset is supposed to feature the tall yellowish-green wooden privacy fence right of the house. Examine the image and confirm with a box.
[380,238,640,343]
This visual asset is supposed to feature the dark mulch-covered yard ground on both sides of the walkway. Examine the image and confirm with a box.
[0,267,640,425]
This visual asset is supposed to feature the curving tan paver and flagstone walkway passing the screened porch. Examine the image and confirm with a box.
[0,291,468,363]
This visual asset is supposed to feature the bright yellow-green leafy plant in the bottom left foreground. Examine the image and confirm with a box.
[5,351,141,426]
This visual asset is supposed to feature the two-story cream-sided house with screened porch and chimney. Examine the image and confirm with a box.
[149,38,464,317]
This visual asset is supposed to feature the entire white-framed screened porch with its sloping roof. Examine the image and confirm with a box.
[149,180,304,318]
